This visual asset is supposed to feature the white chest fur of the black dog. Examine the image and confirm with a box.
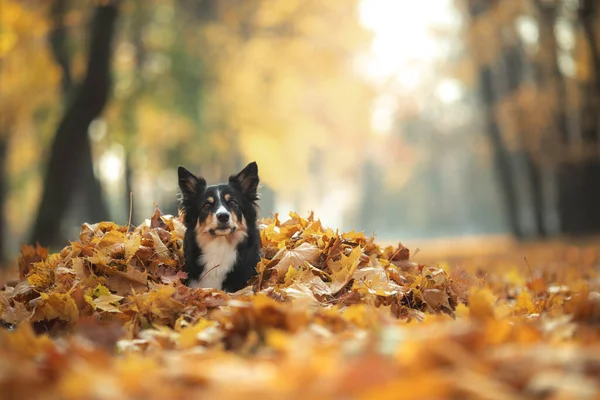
[192,237,237,290]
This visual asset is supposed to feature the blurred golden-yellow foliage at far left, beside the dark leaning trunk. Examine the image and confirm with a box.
[0,0,58,262]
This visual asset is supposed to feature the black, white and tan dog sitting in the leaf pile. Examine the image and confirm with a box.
[178,162,260,292]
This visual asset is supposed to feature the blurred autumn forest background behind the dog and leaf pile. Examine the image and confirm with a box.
[0,0,600,266]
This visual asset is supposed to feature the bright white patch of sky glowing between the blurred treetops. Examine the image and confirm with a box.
[359,0,460,134]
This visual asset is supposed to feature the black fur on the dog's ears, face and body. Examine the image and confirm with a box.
[178,162,260,292]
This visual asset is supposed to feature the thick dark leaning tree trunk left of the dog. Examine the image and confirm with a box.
[31,2,118,246]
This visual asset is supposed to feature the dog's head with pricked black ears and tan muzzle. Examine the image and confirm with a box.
[178,162,259,244]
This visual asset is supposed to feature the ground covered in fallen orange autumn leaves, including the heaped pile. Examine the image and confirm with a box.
[0,211,600,399]
